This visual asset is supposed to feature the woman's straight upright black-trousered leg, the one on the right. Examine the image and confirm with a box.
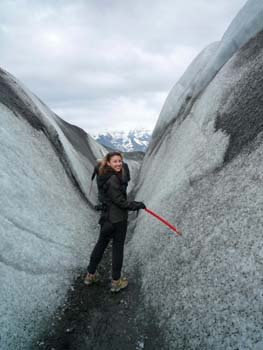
[112,220,128,281]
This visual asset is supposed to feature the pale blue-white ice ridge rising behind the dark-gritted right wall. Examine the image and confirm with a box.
[151,0,263,153]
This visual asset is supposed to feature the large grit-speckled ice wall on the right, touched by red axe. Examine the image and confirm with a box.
[127,1,263,350]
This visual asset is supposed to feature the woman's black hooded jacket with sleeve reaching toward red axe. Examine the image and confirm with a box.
[97,167,139,223]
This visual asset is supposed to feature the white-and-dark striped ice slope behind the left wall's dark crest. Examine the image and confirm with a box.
[0,66,110,203]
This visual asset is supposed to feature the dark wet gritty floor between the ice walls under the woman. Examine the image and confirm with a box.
[32,225,165,350]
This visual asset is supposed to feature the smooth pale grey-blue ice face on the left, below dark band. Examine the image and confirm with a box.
[0,104,97,350]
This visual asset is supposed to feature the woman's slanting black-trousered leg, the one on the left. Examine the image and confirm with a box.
[87,221,114,274]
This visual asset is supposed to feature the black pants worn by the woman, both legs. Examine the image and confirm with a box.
[88,220,127,280]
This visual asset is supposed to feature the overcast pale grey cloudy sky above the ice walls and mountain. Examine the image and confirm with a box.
[0,0,246,133]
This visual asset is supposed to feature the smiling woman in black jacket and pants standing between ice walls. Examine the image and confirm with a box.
[84,152,146,292]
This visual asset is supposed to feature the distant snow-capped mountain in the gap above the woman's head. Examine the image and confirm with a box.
[92,129,152,152]
